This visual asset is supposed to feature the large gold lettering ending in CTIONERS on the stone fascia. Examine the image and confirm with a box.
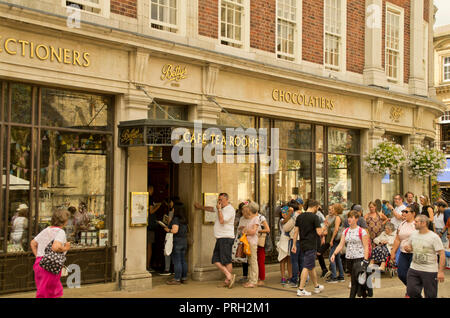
[0,36,91,67]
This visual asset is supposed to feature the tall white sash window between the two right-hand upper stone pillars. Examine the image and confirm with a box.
[385,7,403,81]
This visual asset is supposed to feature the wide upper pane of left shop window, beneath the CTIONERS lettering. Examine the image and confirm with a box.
[41,88,112,130]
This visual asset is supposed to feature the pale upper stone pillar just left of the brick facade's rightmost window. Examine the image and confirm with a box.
[364,0,387,87]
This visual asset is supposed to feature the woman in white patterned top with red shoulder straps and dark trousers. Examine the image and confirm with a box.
[330,210,369,298]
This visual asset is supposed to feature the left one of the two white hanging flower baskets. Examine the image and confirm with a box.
[364,141,406,175]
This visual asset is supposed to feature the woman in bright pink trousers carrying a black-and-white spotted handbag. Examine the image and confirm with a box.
[30,208,70,298]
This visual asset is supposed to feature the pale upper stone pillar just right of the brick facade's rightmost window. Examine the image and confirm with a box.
[409,0,428,96]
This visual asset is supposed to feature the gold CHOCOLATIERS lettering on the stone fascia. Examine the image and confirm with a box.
[272,88,336,110]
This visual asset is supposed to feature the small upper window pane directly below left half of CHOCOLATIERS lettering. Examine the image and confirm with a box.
[275,120,312,149]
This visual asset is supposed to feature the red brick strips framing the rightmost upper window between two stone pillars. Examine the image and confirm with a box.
[381,0,411,83]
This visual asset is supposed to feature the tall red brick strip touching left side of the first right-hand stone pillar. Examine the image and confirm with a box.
[347,0,366,74]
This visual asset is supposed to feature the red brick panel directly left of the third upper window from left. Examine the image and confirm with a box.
[198,0,219,39]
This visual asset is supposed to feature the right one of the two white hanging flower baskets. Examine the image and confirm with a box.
[407,147,447,179]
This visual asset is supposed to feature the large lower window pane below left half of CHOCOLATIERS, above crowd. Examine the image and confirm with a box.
[274,150,312,205]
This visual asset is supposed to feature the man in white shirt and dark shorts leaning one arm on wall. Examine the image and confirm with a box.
[194,193,236,288]
